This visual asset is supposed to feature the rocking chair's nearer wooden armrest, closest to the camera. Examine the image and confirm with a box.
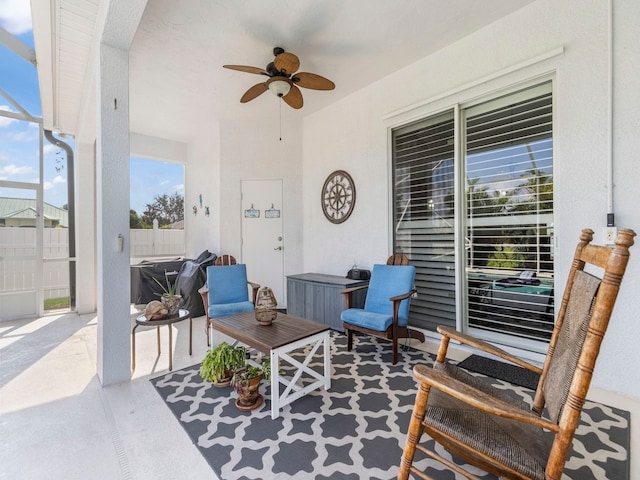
[413,364,560,432]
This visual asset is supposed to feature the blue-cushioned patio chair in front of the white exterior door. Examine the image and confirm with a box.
[199,257,260,346]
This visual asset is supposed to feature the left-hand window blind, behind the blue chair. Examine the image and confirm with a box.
[393,111,456,330]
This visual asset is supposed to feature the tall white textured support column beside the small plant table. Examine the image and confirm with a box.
[96,44,131,385]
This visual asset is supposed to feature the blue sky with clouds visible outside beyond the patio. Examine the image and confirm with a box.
[0,0,184,215]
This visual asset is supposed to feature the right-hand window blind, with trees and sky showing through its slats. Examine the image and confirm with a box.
[464,83,554,340]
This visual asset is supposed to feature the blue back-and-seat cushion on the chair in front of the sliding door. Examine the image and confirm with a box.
[340,265,416,332]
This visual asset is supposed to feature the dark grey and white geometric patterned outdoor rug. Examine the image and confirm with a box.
[151,332,629,480]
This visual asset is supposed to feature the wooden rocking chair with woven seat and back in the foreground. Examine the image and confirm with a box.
[398,229,635,480]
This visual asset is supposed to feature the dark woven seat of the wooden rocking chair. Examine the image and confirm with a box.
[424,363,553,480]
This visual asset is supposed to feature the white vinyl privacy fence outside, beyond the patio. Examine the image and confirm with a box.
[0,227,185,299]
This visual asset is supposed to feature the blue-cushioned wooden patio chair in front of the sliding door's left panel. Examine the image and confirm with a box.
[340,264,424,365]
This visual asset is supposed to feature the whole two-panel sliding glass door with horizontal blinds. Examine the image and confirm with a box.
[392,82,554,352]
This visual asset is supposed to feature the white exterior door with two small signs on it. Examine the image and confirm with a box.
[241,180,286,308]
